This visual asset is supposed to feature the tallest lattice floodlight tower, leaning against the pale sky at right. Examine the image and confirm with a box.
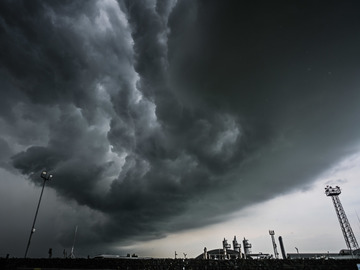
[325,186,359,250]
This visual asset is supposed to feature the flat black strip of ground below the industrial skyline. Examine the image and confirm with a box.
[0,258,360,270]
